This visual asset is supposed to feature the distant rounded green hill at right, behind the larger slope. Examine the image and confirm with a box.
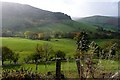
[76,16,120,31]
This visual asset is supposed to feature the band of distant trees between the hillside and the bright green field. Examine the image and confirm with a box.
[1,30,120,40]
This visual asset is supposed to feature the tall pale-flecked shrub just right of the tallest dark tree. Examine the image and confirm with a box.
[85,41,100,78]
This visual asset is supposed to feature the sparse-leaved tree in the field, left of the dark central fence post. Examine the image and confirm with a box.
[29,43,54,70]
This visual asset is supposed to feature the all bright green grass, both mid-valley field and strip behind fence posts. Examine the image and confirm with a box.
[0,37,118,78]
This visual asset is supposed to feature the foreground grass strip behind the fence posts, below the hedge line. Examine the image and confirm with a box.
[3,60,119,78]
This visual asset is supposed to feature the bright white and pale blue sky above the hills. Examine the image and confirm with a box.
[1,0,119,18]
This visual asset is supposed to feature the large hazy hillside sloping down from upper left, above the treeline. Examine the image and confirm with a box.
[2,2,96,33]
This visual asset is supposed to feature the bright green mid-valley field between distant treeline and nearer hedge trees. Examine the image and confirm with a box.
[0,37,112,62]
